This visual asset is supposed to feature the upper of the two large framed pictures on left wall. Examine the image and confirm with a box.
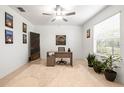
[5,12,13,28]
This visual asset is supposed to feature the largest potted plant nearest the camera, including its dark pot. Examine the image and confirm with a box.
[104,56,120,81]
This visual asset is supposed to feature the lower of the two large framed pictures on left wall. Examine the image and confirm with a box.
[5,30,13,44]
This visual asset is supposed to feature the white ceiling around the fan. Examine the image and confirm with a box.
[10,5,107,25]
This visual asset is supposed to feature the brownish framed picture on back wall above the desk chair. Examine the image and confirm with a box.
[56,35,66,45]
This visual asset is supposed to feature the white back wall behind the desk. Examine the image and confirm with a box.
[34,25,83,59]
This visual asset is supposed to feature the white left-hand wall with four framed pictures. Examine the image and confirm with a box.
[0,6,33,78]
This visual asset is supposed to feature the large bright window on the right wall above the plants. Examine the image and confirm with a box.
[94,13,120,56]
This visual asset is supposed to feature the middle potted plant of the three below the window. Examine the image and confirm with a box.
[93,59,103,73]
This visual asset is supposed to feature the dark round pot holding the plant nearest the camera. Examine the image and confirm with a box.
[104,69,117,81]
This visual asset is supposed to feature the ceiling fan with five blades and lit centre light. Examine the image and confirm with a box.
[42,5,76,22]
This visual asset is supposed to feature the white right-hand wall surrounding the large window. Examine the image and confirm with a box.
[83,6,124,83]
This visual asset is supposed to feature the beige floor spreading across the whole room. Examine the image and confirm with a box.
[0,60,124,87]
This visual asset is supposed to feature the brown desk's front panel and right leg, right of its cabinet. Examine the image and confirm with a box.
[55,52,73,66]
